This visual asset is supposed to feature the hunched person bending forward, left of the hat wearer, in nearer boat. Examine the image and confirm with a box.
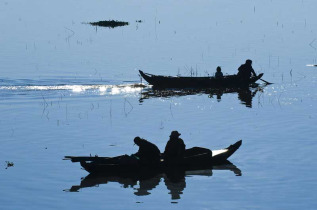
[134,136,161,165]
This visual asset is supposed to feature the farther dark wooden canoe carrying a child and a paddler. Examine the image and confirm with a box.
[139,70,263,88]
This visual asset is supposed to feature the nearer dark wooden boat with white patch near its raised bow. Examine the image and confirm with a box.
[64,140,242,174]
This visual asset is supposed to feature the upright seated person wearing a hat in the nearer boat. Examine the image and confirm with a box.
[164,131,186,161]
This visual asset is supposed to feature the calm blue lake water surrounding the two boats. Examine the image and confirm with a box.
[0,0,317,210]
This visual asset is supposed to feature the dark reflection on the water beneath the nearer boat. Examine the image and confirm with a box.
[65,161,242,200]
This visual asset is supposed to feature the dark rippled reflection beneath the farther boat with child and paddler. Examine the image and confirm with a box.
[139,86,264,108]
